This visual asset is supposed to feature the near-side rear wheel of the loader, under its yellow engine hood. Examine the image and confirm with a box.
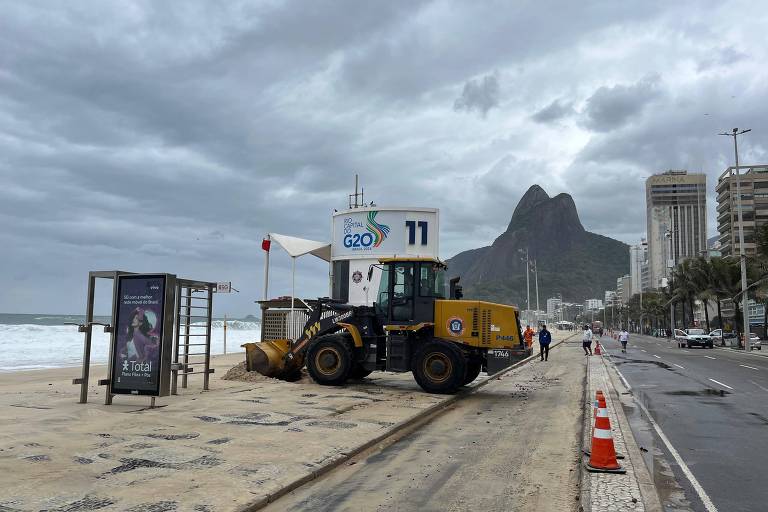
[411,340,467,394]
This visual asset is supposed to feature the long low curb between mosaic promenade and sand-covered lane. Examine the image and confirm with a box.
[237,333,577,512]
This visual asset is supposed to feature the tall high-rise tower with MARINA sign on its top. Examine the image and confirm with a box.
[645,171,707,288]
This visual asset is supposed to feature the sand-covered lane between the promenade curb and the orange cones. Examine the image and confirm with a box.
[265,343,585,512]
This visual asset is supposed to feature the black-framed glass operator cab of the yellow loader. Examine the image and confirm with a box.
[376,258,446,325]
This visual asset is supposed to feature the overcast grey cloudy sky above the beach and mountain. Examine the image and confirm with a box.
[0,0,768,315]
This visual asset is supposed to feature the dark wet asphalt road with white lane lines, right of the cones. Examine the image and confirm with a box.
[603,335,768,512]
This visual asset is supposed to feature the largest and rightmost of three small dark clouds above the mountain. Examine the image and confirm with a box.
[584,75,660,132]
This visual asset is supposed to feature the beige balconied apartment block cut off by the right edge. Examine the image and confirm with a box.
[715,165,768,256]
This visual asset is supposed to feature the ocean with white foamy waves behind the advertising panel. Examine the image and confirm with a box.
[0,313,261,372]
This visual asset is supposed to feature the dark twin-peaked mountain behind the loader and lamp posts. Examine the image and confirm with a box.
[448,185,629,312]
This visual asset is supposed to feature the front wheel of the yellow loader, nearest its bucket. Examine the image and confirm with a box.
[306,334,353,386]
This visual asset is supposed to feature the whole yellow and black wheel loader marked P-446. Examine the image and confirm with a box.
[248,258,523,393]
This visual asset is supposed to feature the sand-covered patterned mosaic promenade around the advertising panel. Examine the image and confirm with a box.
[0,354,445,512]
